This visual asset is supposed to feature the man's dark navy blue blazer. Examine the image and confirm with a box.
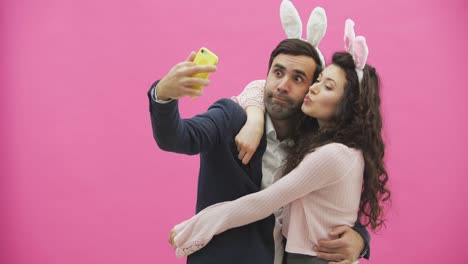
[148,83,275,264]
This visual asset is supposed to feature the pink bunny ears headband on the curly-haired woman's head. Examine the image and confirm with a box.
[344,19,369,83]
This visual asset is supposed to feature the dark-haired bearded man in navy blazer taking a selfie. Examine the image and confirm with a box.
[148,39,369,264]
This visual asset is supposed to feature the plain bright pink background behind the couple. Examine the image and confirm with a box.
[0,0,468,264]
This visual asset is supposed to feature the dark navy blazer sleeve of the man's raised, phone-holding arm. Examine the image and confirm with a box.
[148,82,246,155]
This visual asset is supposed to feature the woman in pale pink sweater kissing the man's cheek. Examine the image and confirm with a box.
[171,21,390,264]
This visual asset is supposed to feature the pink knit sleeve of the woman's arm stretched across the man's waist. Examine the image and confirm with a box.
[174,143,358,257]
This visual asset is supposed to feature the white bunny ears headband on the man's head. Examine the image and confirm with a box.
[280,0,327,67]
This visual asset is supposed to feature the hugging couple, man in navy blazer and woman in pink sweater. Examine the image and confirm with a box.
[148,16,390,264]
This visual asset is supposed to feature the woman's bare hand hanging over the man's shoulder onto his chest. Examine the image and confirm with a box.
[235,106,265,165]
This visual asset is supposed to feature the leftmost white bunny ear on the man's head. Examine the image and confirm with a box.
[280,0,302,39]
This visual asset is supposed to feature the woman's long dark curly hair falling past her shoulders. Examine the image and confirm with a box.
[284,52,391,230]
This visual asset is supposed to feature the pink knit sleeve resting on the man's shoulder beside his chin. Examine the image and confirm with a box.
[231,80,265,110]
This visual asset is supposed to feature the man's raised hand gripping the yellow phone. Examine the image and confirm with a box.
[155,48,217,100]
